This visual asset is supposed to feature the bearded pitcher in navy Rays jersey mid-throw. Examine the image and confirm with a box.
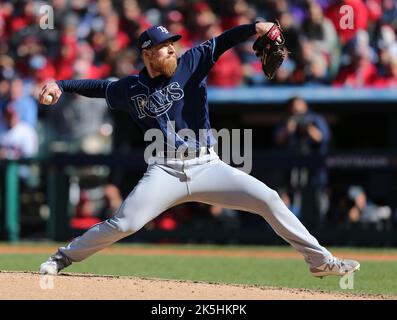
[39,21,360,277]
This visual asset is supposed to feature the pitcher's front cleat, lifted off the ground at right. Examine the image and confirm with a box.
[310,257,360,278]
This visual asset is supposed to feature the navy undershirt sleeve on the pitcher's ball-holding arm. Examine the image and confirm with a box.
[56,79,110,98]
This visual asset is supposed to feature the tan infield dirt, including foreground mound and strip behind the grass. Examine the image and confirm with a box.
[0,245,397,300]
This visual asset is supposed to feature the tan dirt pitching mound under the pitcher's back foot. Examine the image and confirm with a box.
[0,272,382,300]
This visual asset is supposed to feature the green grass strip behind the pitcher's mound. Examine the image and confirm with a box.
[0,244,397,296]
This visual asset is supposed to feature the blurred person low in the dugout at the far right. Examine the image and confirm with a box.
[348,186,392,223]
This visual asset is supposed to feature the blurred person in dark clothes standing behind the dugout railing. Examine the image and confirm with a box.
[275,97,331,225]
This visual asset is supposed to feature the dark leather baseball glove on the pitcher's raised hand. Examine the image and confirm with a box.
[252,21,288,79]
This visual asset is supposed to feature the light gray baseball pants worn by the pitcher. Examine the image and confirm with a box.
[59,149,332,267]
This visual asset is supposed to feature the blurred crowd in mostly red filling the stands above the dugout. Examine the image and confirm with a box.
[0,0,397,95]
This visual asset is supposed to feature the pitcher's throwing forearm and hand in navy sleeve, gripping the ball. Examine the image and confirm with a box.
[39,79,110,104]
